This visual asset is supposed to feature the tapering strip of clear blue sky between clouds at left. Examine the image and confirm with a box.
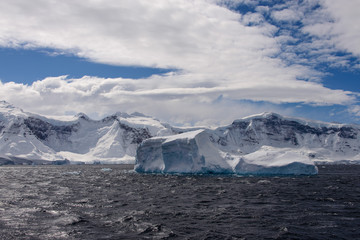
[0,48,171,85]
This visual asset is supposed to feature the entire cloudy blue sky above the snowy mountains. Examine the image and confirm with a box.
[0,0,360,126]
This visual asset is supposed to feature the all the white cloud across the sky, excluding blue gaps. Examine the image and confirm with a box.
[0,0,357,125]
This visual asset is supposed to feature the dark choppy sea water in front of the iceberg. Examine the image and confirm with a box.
[0,165,360,239]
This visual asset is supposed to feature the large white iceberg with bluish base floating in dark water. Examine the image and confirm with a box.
[135,129,317,175]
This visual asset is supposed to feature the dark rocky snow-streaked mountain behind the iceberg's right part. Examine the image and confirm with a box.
[211,113,360,161]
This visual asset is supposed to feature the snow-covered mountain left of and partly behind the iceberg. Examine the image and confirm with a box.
[0,101,176,164]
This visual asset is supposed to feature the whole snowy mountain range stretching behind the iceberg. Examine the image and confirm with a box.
[0,101,360,165]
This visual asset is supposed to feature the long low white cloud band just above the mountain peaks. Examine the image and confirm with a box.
[0,74,354,124]
